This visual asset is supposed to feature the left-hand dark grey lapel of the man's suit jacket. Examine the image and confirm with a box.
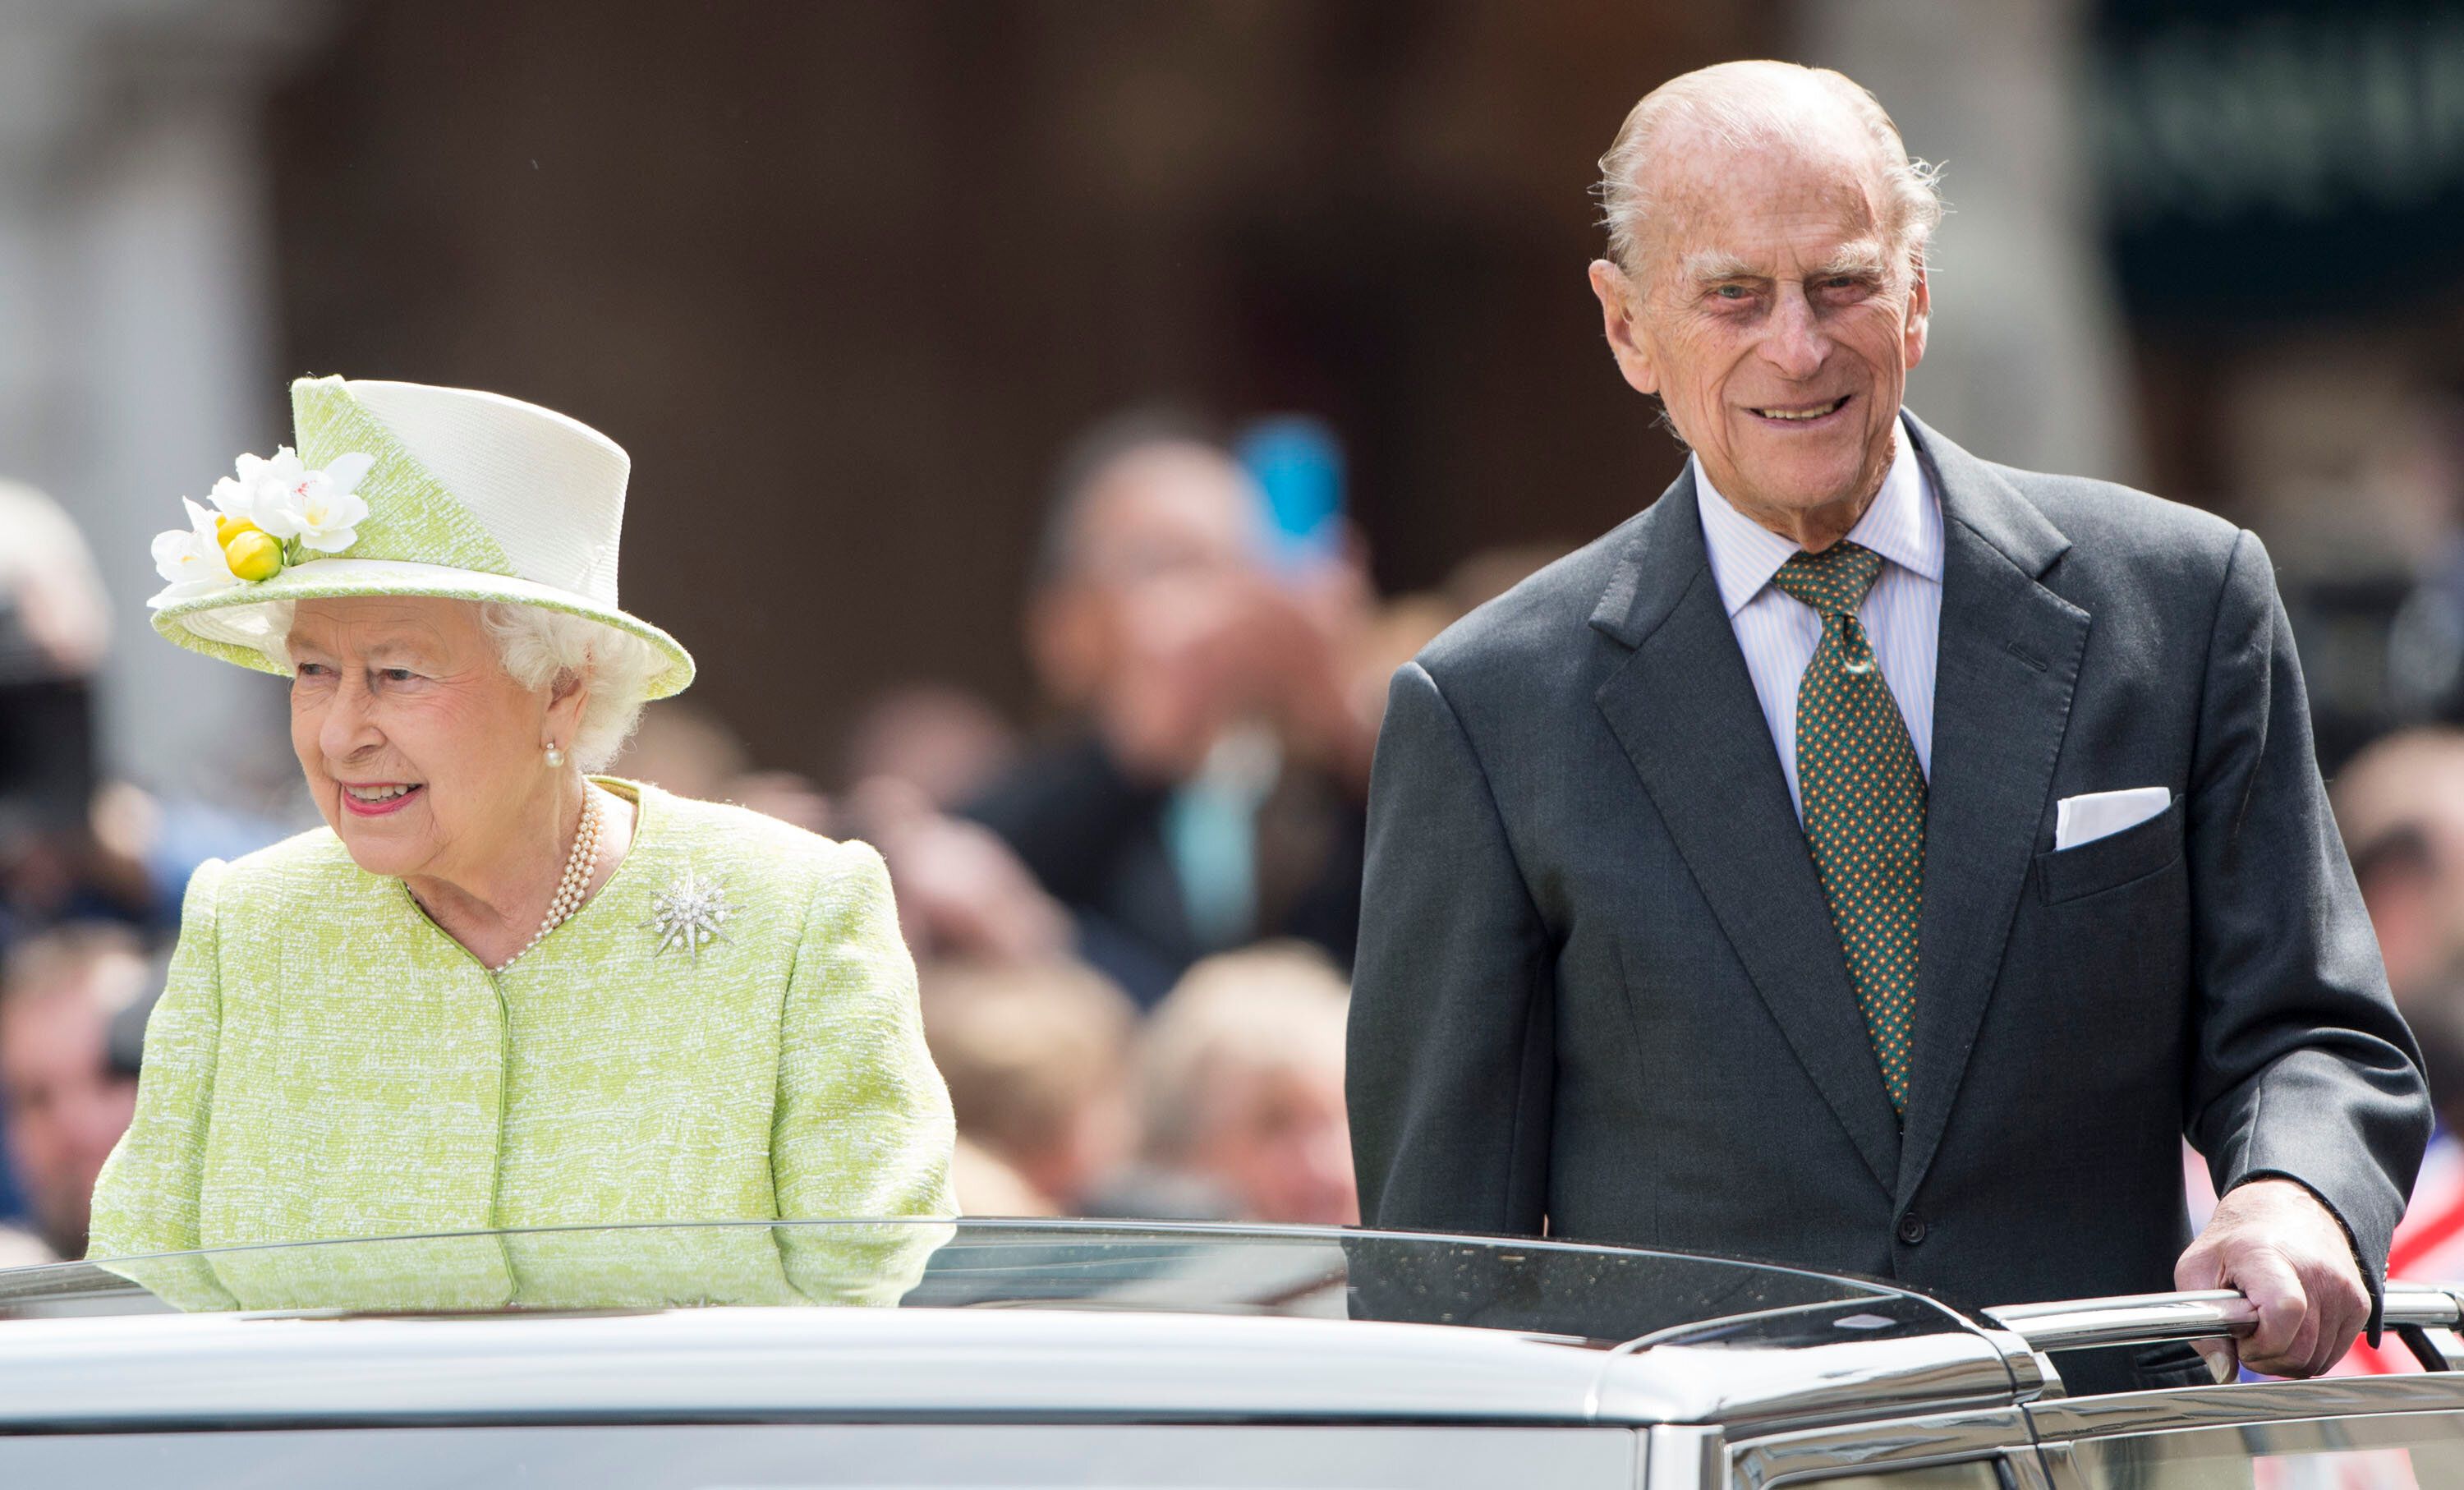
[1592,468,1922,1189]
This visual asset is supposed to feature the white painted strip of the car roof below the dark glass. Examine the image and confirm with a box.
[0,1308,2013,1428]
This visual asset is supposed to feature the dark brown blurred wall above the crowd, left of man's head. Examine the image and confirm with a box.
[264,0,1735,743]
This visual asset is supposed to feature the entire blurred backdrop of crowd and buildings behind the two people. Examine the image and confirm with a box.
[0,0,2464,1281]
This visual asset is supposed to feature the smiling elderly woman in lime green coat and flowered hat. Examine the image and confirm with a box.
[91,377,951,1308]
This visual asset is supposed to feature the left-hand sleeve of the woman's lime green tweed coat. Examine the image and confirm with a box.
[89,859,232,1308]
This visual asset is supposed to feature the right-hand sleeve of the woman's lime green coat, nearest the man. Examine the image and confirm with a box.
[771,842,956,1303]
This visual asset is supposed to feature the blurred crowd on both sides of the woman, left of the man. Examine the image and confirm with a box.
[0,412,1552,1241]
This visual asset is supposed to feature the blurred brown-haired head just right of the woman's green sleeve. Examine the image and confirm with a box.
[919,958,1138,1216]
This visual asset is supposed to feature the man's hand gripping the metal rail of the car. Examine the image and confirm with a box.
[2173,1180,2370,1382]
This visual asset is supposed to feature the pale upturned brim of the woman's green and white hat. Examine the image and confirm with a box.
[153,559,692,700]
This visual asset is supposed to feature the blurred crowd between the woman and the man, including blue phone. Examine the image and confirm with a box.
[616,412,1552,1224]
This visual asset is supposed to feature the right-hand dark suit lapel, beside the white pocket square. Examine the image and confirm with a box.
[1897,419,2089,1204]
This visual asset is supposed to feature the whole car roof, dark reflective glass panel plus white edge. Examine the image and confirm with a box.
[0,1221,2043,1426]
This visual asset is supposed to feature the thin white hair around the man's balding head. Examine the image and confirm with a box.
[1597,62,1942,274]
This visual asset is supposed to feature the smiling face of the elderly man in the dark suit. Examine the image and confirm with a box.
[1592,126,1927,547]
